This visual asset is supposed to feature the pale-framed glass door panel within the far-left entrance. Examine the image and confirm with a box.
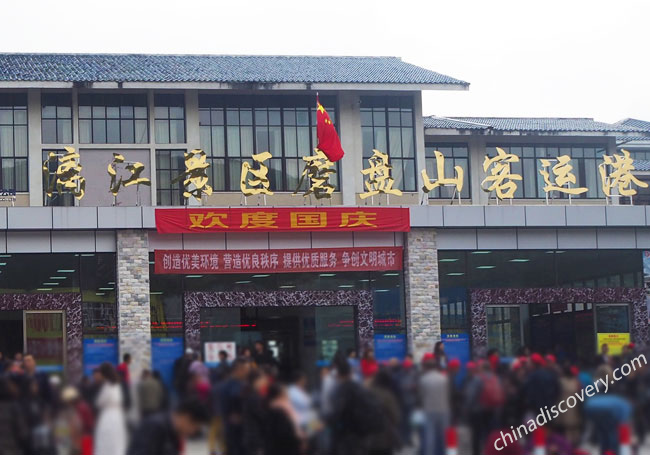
[23,311,65,375]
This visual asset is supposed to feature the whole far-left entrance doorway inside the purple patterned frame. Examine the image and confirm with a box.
[0,310,66,375]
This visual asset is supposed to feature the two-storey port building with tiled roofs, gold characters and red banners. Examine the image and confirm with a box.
[0,54,650,381]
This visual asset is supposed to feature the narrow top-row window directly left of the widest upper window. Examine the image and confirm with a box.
[154,94,185,144]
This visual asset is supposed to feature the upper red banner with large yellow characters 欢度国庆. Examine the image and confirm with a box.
[156,207,411,234]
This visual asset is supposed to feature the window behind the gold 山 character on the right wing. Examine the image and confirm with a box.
[425,144,471,199]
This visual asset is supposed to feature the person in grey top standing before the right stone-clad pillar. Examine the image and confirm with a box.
[418,353,451,455]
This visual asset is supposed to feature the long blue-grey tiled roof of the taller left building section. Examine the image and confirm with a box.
[0,54,468,86]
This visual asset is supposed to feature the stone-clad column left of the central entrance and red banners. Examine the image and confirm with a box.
[117,229,151,382]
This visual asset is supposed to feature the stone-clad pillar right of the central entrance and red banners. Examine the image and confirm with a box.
[404,229,441,360]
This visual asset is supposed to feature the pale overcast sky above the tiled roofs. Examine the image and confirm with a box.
[0,0,650,122]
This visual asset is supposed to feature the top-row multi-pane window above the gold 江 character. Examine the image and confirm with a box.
[79,94,149,144]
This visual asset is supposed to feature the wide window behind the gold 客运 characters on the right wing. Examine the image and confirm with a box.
[486,144,607,199]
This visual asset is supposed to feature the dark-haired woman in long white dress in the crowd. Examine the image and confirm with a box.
[93,363,127,455]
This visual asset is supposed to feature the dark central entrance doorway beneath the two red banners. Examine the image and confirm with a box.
[200,306,357,380]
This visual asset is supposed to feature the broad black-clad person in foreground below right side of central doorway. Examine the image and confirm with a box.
[328,361,384,455]
